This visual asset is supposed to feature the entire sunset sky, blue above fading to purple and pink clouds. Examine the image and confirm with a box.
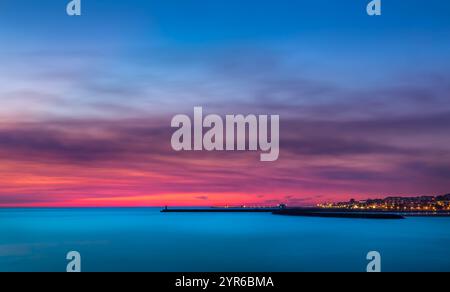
[0,0,450,207]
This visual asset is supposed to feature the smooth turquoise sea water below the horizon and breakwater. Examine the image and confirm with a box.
[0,208,450,272]
